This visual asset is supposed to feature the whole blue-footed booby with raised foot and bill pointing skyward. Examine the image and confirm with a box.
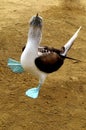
[8,13,81,99]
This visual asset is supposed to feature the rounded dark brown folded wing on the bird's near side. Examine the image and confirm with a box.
[35,52,64,73]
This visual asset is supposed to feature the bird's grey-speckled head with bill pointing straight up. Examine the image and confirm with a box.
[30,13,43,28]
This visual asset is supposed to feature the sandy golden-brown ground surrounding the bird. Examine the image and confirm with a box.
[0,0,86,130]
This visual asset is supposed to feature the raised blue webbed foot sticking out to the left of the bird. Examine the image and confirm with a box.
[7,58,24,73]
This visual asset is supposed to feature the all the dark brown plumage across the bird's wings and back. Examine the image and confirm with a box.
[22,46,65,73]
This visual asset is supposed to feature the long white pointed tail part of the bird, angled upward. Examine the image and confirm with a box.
[60,27,81,56]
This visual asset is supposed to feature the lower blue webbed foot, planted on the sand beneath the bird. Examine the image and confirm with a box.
[26,86,41,98]
